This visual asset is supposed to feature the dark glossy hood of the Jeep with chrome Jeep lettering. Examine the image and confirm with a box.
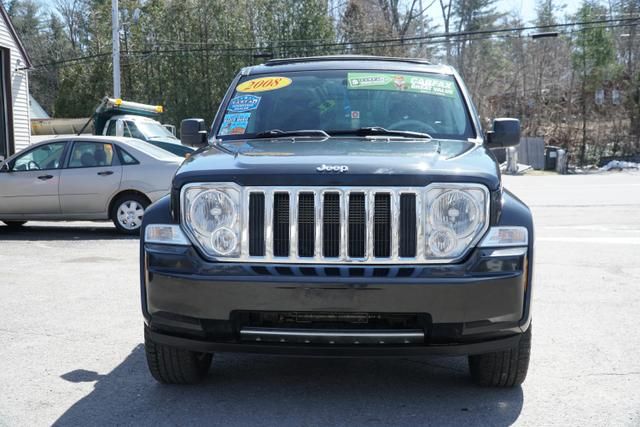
[174,137,500,190]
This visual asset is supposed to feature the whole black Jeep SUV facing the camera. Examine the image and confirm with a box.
[140,56,533,387]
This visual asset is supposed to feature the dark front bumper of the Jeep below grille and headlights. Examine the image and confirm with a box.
[142,243,530,356]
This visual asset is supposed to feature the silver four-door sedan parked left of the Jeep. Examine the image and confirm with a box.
[0,135,184,234]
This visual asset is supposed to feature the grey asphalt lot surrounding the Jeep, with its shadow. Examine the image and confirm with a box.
[0,173,640,426]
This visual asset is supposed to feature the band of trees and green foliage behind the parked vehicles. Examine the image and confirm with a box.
[5,0,640,162]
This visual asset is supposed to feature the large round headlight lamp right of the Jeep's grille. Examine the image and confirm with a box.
[429,190,481,237]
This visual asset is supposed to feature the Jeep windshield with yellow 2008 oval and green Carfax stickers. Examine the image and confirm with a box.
[216,70,475,140]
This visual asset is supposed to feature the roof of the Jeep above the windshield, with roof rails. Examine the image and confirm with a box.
[242,55,453,75]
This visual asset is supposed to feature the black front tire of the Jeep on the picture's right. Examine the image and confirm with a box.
[469,325,531,388]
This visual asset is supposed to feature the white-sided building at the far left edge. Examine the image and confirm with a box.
[0,3,31,159]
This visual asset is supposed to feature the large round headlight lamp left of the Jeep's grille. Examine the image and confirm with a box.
[189,190,237,236]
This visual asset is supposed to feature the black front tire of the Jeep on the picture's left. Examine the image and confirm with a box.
[144,328,213,384]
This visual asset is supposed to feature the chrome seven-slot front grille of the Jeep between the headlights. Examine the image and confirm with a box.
[242,187,424,263]
